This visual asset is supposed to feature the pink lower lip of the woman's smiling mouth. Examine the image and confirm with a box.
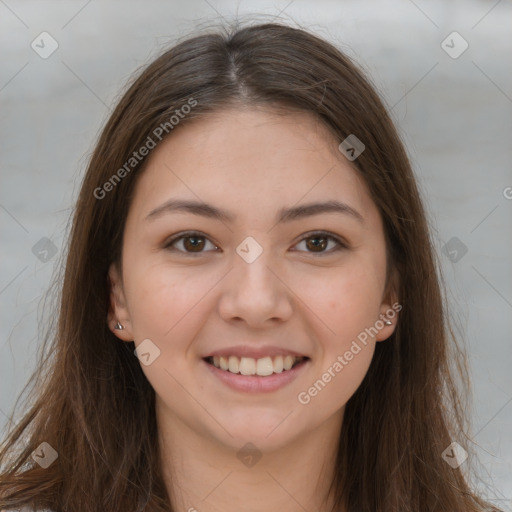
[203,359,309,393]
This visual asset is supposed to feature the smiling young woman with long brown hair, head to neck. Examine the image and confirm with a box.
[0,24,504,512]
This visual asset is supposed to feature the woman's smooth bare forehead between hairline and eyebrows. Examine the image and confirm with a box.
[127,108,378,228]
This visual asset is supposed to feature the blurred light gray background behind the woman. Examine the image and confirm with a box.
[0,0,512,510]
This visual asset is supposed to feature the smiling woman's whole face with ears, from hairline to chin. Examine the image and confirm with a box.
[109,109,396,449]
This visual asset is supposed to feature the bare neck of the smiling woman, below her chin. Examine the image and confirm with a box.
[157,407,343,512]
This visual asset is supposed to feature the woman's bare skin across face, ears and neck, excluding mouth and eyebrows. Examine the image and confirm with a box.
[108,107,397,512]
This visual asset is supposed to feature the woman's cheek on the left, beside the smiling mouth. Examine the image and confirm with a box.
[125,265,218,409]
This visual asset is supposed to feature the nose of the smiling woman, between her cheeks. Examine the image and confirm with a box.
[218,251,293,328]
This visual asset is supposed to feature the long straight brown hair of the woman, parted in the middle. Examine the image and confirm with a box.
[0,23,500,512]
